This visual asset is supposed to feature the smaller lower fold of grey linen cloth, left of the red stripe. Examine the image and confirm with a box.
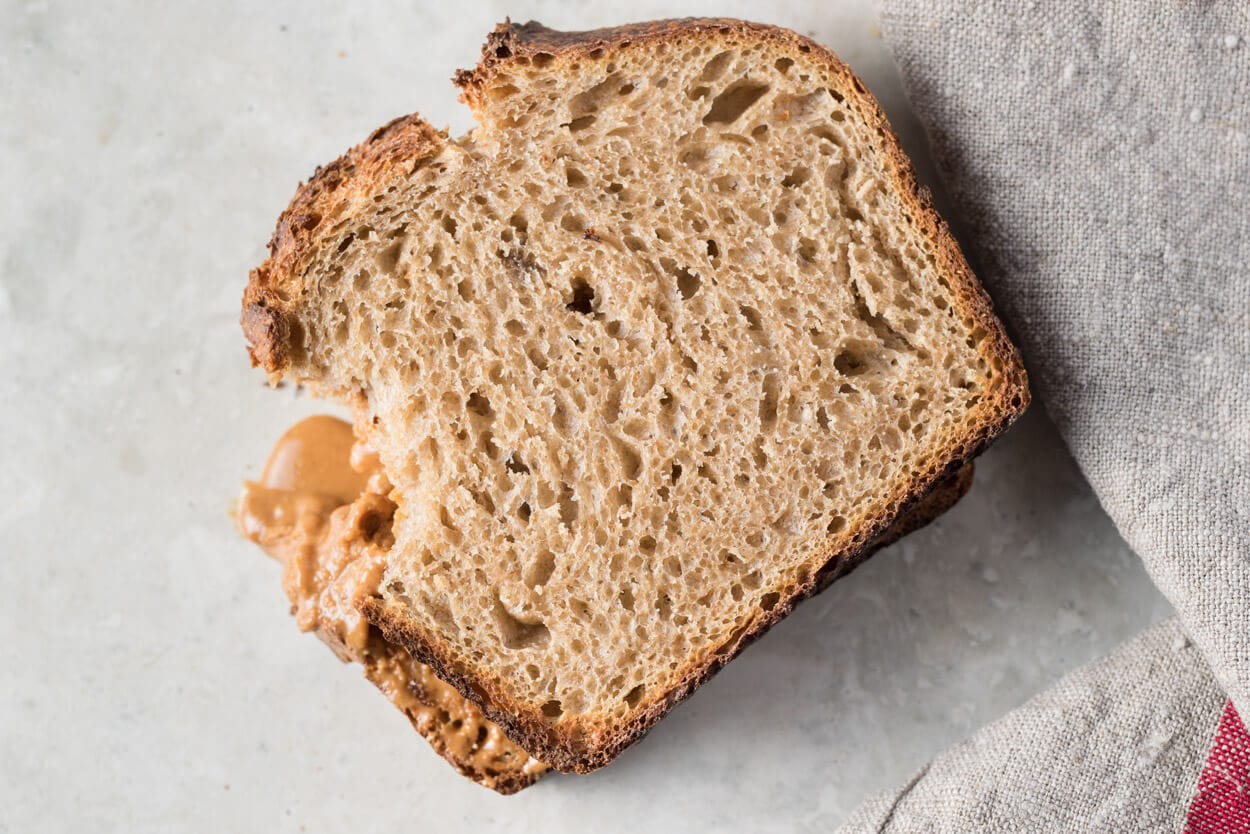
[841,620,1225,834]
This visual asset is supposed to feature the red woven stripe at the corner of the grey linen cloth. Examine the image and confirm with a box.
[1185,701,1250,834]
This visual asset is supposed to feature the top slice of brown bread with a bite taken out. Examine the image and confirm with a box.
[243,20,1029,771]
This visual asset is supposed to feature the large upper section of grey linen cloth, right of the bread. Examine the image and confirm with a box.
[883,0,1250,715]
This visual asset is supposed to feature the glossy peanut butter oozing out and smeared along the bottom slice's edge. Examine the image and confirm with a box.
[238,416,546,790]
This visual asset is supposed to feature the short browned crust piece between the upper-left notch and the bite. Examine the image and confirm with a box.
[239,114,448,380]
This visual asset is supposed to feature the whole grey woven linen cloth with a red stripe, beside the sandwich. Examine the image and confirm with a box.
[846,0,1250,831]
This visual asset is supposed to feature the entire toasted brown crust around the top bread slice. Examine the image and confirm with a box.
[244,19,1030,773]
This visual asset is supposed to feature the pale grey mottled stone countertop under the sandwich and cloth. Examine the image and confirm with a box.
[0,0,1168,833]
